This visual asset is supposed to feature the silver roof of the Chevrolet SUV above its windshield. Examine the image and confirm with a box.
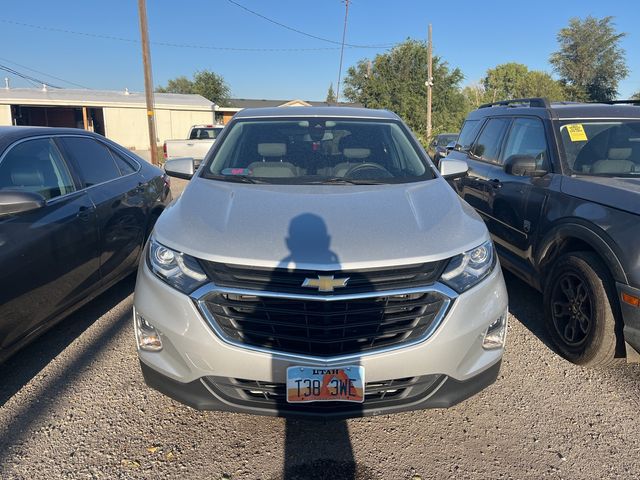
[235,106,398,120]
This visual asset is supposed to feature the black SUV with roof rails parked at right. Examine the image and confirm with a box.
[447,98,640,365]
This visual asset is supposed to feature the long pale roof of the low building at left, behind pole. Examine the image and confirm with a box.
[0,87,214,111]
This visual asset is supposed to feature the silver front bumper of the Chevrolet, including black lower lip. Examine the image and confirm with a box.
[134,262,507,418]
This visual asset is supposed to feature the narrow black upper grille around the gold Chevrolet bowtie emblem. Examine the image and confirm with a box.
[200,260,448,295]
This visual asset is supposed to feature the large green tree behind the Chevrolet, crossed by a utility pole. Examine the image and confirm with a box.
[344,40,467,141]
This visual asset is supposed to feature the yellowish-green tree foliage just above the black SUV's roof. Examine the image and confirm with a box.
[482,62,566,102]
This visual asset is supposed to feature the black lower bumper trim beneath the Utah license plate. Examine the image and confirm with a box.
[140,360,501,420]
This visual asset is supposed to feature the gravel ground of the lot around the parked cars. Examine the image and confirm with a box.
[0,178,640,480]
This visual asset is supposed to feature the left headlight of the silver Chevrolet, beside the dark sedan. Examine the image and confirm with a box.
[147,237,207,294]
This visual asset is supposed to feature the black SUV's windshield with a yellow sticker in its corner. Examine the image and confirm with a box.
[560,120,640,176]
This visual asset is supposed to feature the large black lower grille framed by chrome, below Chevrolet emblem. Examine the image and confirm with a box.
[199,291,449,356]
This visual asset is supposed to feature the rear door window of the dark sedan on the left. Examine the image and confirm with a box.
[60,137,120,187]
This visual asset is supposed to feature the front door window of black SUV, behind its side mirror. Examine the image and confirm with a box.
[502,118,547,168]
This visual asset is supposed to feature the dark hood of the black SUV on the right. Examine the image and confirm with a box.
[561,175,640,215]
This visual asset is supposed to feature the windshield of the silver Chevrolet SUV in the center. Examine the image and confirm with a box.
[203,117,433,184]
